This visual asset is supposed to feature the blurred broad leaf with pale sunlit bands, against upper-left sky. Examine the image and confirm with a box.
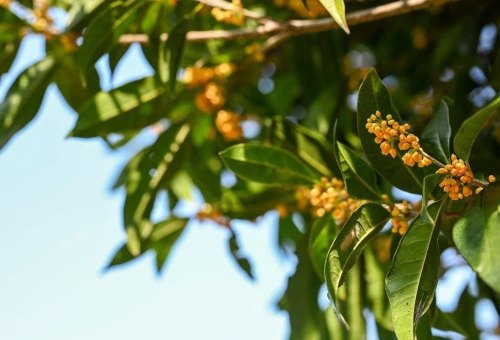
[70,77,166,138]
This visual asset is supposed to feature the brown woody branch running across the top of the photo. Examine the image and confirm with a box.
[119,0,459,44]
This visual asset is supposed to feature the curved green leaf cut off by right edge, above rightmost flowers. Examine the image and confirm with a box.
[453,97,500,161]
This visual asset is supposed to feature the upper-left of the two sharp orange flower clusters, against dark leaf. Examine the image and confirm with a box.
[365,111,432,168]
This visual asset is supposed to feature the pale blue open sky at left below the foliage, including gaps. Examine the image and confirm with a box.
[0,37,293,340]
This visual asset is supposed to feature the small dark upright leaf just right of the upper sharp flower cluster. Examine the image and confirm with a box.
[421,100,451,164]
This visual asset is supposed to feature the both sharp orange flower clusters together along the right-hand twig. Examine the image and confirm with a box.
[365,111,495,200]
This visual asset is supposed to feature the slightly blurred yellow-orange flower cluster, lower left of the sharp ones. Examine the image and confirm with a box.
[297,177,361,225]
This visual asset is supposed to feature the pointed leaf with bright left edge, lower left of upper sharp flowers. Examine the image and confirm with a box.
[337,142,382,201]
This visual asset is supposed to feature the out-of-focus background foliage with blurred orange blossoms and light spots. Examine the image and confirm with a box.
[0,0,500,339]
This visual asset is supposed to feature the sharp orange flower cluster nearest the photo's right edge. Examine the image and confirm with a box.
[436,154,496,200]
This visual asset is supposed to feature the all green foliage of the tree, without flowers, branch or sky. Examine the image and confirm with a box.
[0,0,500,339]
